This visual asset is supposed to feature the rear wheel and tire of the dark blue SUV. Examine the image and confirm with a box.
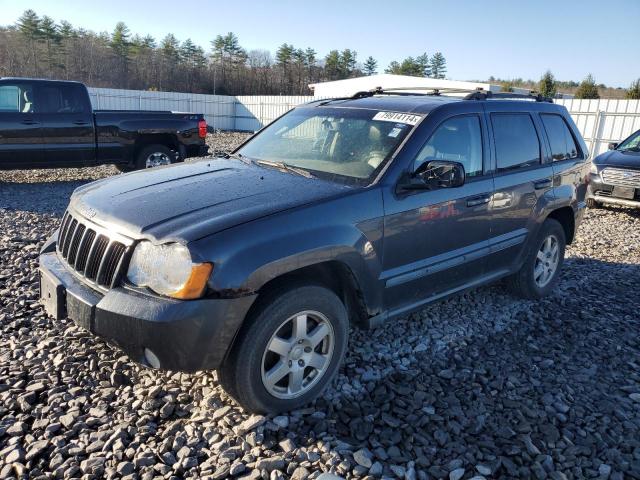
[506,218,566,300]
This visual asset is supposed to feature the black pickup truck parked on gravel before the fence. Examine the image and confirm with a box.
[0,78,208,171]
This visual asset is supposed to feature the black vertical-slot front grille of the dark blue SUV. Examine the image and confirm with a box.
[57,211,132,290]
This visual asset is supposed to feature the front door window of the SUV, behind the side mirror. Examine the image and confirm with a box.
[414,115,482,177]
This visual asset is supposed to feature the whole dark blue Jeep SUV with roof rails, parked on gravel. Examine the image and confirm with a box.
[40,90,589,412]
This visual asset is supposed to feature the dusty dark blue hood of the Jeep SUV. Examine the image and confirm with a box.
[70,159,351,242]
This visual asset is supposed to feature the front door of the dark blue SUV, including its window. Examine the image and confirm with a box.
[382,109,493,314]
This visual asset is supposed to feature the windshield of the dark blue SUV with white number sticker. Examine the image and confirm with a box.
[237,107,421,184]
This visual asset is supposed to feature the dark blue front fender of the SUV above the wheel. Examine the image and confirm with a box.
[192,191,383,311]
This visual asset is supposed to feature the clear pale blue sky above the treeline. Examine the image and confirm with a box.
[0,0,640,87]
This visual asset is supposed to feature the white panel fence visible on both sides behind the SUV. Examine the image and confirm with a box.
[89,88,640,156]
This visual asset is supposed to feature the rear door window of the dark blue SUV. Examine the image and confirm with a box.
[491,113,540,171]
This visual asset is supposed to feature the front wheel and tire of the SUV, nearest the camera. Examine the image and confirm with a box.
[218,285,349,413]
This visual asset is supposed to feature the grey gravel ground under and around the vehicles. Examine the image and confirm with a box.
[0,134,640,480]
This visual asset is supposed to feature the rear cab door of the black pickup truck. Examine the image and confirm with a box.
[36,82,96,167]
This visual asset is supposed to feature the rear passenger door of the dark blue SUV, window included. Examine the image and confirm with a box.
[486,108,554,272]
